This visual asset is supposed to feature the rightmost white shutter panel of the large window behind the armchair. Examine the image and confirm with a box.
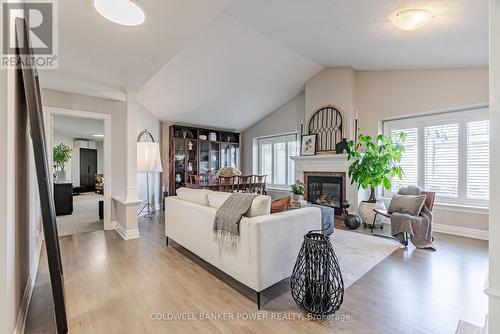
[467,120,490,201]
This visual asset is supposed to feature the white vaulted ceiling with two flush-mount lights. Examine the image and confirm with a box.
[41,0,488,130]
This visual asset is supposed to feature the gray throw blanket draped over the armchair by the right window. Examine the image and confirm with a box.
[391,186,436,250]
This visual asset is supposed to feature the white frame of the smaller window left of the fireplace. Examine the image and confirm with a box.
[257,133,299,189]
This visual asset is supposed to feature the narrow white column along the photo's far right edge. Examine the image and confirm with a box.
[486,0,500,333]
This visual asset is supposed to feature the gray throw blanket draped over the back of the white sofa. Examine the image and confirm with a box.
[213,193,258,248]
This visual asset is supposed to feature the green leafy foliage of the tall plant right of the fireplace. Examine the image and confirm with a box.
[347,132,406,203]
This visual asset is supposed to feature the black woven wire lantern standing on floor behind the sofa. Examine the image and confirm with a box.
[290,231,344,317]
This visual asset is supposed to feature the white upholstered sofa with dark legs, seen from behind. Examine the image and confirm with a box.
[165,188,321,308]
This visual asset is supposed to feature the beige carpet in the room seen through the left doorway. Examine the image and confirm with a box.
[56,193,104,237]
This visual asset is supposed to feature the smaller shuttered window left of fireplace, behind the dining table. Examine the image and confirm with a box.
[258,134,298,188]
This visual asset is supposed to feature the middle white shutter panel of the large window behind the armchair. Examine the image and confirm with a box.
[424,124,459,198]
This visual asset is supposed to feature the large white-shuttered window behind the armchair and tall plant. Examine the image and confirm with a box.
[384,108,489,205]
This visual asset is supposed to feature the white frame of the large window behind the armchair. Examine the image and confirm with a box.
[381,106,491,207]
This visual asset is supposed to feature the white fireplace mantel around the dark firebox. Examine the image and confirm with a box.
[290,154,368,213]
